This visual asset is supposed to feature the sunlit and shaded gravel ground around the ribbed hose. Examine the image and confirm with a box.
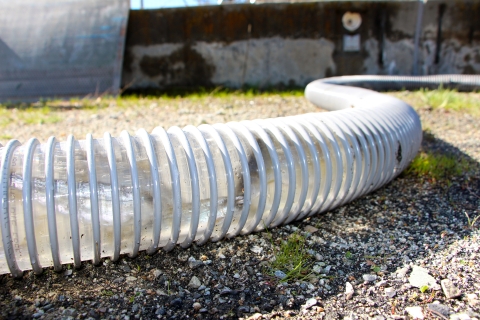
[0,91,480,319]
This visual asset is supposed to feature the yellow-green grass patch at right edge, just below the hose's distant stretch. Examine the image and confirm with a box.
[418,88,480,116]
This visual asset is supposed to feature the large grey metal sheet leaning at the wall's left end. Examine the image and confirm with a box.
[0,0,130,101]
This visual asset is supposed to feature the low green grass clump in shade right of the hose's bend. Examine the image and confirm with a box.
[405,152,471,181]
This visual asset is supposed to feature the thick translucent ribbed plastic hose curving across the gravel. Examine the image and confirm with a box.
[0,77,476,277]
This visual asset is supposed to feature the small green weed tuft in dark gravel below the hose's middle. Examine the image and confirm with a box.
[270,233,311,282]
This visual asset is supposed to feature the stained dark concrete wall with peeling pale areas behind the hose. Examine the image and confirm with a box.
[122,0,480,89]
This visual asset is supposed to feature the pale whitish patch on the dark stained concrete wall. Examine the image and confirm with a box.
[193,37,336,87]
